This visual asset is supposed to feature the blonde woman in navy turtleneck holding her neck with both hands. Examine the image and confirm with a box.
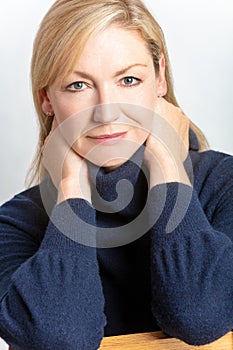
[0,0,233,350]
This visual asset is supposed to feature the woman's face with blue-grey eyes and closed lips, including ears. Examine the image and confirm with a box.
[42,26,165,168]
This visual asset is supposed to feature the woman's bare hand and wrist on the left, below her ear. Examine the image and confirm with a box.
[41,117,91,203]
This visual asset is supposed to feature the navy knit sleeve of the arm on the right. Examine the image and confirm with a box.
[150,183,233,345]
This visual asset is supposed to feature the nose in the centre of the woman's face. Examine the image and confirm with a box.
[94,86,120,124]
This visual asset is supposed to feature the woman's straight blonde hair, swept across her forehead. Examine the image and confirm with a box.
[28,0,207,184]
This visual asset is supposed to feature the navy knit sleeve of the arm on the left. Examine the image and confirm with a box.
[0,191,105,350]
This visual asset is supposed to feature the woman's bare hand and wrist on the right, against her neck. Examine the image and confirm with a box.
[145,97,190,187]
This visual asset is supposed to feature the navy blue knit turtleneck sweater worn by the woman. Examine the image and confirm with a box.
[0,135,233,350]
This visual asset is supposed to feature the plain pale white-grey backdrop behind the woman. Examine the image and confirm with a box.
[0,0,233,350]
